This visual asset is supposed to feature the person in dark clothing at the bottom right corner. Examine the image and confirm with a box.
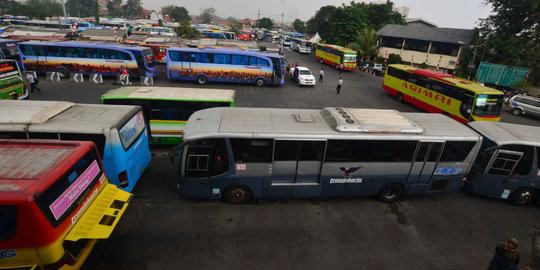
[487,237,520,270]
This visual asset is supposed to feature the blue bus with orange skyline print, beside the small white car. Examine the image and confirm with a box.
[167,47,285,87]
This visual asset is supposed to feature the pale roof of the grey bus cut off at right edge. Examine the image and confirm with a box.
[468,121,540,146]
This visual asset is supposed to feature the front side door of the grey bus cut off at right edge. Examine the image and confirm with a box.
[479,149,523,199]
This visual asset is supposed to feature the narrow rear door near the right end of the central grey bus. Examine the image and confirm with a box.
[408,141,444,194]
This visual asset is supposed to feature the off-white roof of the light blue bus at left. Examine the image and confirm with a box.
[0,100,140,134]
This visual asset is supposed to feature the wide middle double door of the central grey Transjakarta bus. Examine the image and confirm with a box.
[266,140,326,198]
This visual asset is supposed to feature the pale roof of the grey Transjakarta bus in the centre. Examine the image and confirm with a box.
[183,107,479,141]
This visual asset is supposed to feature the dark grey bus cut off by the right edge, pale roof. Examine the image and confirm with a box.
[465,122,540,205]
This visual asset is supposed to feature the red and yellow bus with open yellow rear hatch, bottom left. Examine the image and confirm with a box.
[0,139,132,269]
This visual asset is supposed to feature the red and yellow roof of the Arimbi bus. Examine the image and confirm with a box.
[389,64,503,95]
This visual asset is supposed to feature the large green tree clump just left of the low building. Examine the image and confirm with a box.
[307,1,405,45]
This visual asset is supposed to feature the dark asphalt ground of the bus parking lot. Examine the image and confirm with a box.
[31,51,540,269]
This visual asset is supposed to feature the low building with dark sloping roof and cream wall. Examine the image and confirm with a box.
[377,19,472,73]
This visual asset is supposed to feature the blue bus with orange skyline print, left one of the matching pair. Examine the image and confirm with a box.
[18,41,158,78]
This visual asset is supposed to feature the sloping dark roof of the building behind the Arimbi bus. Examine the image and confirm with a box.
[377,24,472,45]
